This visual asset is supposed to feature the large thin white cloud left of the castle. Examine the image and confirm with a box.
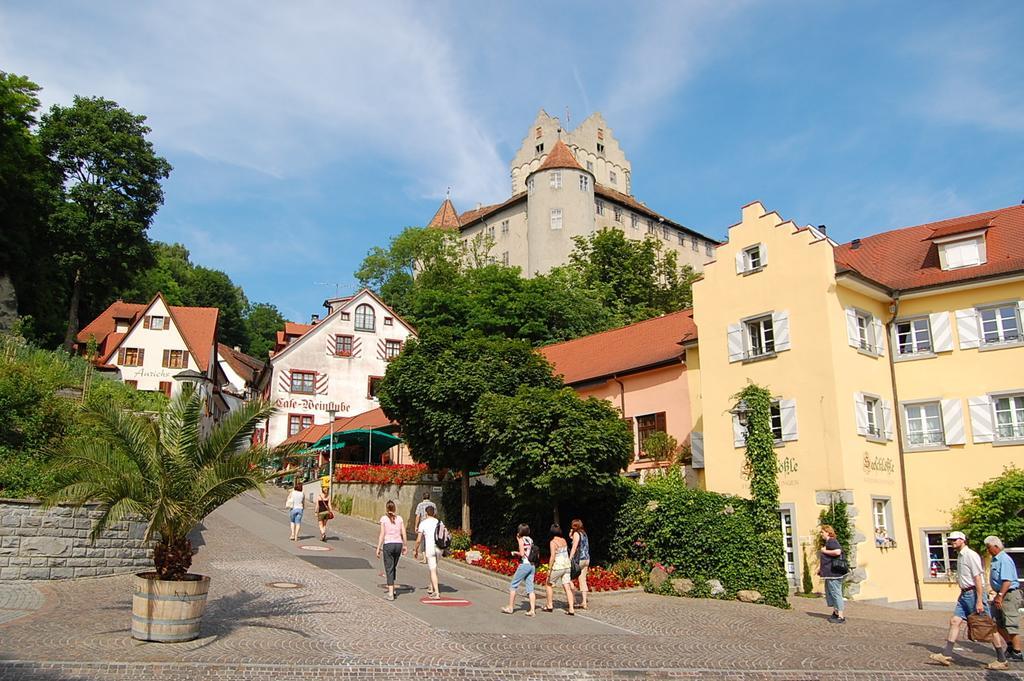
[0,2,507,197]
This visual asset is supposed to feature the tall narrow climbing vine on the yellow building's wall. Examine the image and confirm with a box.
[734,384,790,607]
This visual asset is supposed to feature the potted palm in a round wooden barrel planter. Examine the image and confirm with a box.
[47,383,282,642]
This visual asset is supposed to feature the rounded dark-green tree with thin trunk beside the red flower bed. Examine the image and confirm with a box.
[378,333,560,531]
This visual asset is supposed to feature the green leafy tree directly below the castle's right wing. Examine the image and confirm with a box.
[568,229,696,324]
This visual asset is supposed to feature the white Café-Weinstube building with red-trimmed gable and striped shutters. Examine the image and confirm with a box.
[261,289,416,445]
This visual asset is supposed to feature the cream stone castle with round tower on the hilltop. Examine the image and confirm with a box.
[429,111,717,276]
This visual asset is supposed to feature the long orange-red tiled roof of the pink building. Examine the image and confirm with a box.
[540,309,697,385]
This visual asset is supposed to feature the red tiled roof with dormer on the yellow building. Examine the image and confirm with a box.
[835,206,1024,290]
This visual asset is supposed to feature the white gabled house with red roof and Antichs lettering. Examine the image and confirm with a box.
[76,293,219,397]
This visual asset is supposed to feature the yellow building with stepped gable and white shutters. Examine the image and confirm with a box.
[684,203,1024,605]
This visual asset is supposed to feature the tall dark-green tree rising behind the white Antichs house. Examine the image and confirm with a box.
[39,96,171,350]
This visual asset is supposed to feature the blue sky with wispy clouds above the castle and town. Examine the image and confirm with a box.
[0,0,1024,321]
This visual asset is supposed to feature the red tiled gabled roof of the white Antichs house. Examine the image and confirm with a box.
[76,293,220,372]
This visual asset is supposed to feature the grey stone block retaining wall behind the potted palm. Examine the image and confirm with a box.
[0,499,153,580]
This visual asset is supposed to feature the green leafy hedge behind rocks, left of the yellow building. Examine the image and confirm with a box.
[612,468,778,604]
